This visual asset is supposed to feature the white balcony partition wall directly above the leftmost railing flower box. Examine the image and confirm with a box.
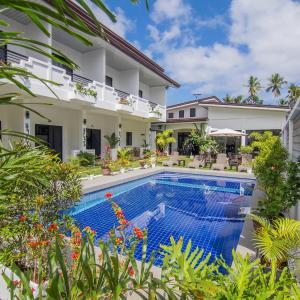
[80,48,106,83]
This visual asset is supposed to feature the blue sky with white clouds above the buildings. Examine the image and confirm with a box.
[91,0,300,105]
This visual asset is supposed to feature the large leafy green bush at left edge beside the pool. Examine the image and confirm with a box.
[0,144,81,266]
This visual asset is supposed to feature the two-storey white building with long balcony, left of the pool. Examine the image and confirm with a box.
[0,1,179,160]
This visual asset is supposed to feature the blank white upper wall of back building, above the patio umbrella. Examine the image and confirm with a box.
[208,107,287,130]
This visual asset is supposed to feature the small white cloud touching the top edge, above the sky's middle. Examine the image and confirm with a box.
[151,0,191,23]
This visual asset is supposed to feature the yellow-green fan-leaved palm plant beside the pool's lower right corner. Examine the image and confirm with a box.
[251,215,300,267]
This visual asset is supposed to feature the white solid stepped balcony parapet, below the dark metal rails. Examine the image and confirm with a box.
[8,52,166,121]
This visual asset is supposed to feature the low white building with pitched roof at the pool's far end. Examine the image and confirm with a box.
[152,96,289,153]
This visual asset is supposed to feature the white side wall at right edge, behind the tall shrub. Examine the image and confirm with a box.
[282,99,300,220]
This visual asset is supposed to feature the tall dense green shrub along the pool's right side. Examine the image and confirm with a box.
[250,131,300,218]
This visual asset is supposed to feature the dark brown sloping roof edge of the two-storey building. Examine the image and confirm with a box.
[44,0,180,87]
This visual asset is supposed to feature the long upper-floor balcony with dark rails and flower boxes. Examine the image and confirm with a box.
[0,49,165,121]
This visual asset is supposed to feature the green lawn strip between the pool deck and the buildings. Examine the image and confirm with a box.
[79,156,241,177]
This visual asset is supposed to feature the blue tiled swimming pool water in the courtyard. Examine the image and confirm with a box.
[69,172,254,265]
